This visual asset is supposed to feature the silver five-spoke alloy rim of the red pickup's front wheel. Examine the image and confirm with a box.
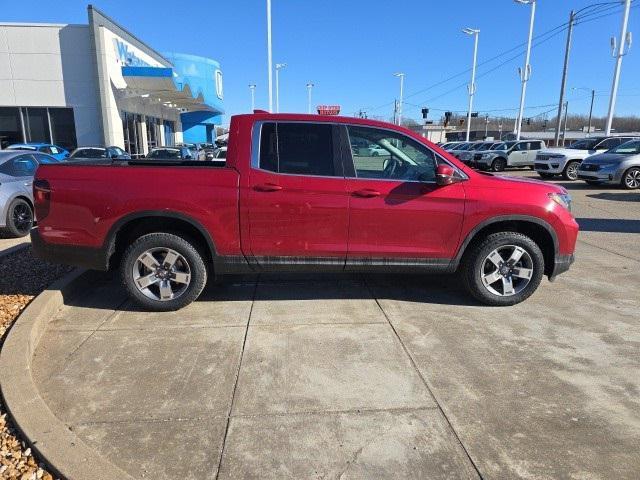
[481,245,533,297]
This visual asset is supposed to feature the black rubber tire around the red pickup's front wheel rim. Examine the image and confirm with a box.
[460,232,544,306]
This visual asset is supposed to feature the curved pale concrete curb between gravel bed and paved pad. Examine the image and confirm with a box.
[0,269,133,480]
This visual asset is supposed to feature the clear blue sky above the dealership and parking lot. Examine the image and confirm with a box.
[0,0,640,124]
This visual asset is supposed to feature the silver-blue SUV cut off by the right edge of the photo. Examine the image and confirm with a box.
[578,140,640,190]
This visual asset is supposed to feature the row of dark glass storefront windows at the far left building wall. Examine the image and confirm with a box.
[0,107,77,150]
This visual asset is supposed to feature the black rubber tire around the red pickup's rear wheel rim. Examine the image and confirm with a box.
[120,233,207,312]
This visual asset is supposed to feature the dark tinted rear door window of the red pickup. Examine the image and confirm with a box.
[260,122,336,177]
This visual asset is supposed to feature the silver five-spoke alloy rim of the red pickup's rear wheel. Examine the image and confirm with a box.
[133,248,191,302]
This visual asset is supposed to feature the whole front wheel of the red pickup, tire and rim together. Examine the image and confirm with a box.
[461,232,544,306]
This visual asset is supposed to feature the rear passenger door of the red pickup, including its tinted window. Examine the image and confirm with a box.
[248,122,349,268]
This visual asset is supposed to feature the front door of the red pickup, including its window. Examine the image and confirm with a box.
[347,126,465,268]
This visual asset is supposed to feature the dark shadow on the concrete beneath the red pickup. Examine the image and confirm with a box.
[63,272,480,312]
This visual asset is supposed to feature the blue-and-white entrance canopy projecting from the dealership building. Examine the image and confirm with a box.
[122,66,222,113]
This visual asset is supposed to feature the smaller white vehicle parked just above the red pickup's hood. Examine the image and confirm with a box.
[473,140,546,172]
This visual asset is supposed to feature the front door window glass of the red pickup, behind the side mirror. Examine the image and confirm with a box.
[348,126,436,182]
